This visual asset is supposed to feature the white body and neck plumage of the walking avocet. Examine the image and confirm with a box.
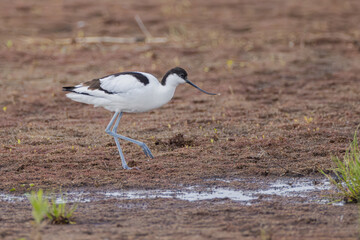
[66,72,180,112]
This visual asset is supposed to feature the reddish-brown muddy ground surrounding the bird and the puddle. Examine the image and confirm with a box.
[0,0,360,239]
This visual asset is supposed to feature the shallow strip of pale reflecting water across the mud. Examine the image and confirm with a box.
[0,179,330,204]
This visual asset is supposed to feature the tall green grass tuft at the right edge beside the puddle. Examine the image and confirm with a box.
[320,130,360,203]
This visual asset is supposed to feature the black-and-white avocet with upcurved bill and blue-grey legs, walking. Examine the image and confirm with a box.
[63,67,216,169]
